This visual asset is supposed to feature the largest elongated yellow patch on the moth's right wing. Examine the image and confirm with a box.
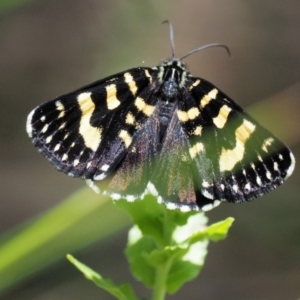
[219,120,255,171]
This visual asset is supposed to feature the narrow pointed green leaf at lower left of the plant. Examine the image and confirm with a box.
[67,254,138,300]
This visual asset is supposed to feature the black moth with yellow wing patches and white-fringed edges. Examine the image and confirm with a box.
[27,24,295,211]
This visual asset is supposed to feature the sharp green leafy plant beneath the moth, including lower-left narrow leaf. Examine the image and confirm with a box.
[67,196,233,300]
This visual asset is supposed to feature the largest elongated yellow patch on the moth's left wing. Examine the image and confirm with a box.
[77,92,102,151]
